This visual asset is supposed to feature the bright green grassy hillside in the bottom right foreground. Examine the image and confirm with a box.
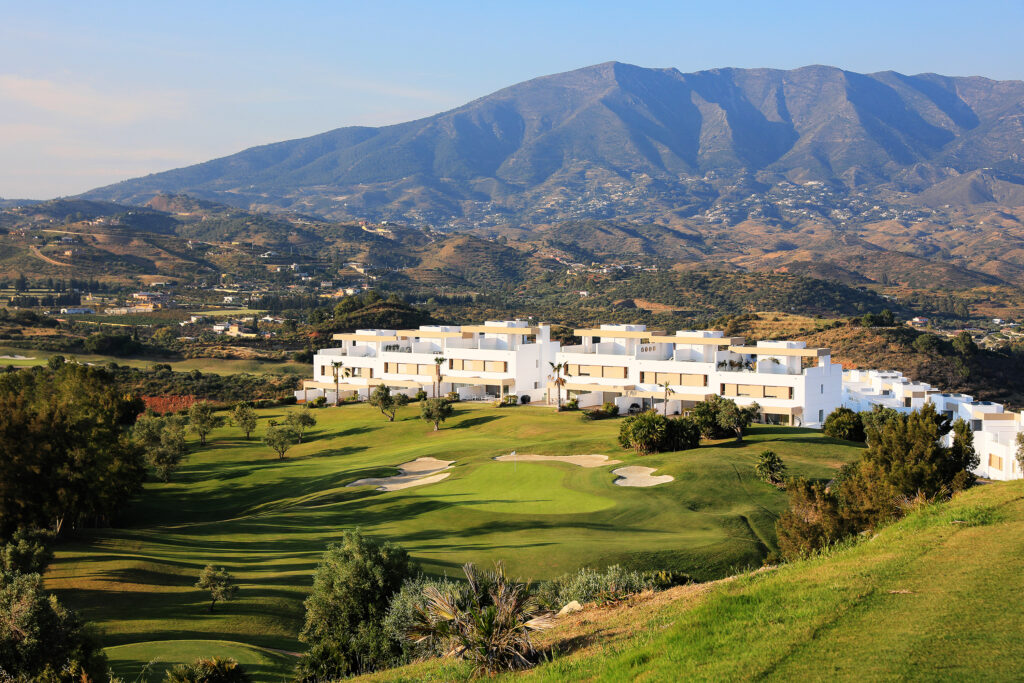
[364,481,1024,681]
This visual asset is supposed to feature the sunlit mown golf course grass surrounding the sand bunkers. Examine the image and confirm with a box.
[47,403,858,680]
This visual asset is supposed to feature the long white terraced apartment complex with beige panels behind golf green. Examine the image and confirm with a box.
[296,321,842,427]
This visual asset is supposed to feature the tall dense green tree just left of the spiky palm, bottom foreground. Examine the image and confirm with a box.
[298,529,415,683]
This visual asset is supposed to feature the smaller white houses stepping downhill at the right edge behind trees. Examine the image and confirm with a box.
[843,370,1024,480]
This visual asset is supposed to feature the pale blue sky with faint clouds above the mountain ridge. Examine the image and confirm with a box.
[0,0,1024,199]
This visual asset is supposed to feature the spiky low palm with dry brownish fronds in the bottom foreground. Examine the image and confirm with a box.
[409,562,554,676]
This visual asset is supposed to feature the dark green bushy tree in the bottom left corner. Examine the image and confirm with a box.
[0,572,108,683]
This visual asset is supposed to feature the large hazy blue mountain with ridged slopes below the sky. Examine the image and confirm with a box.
[88,62,1024,222]
